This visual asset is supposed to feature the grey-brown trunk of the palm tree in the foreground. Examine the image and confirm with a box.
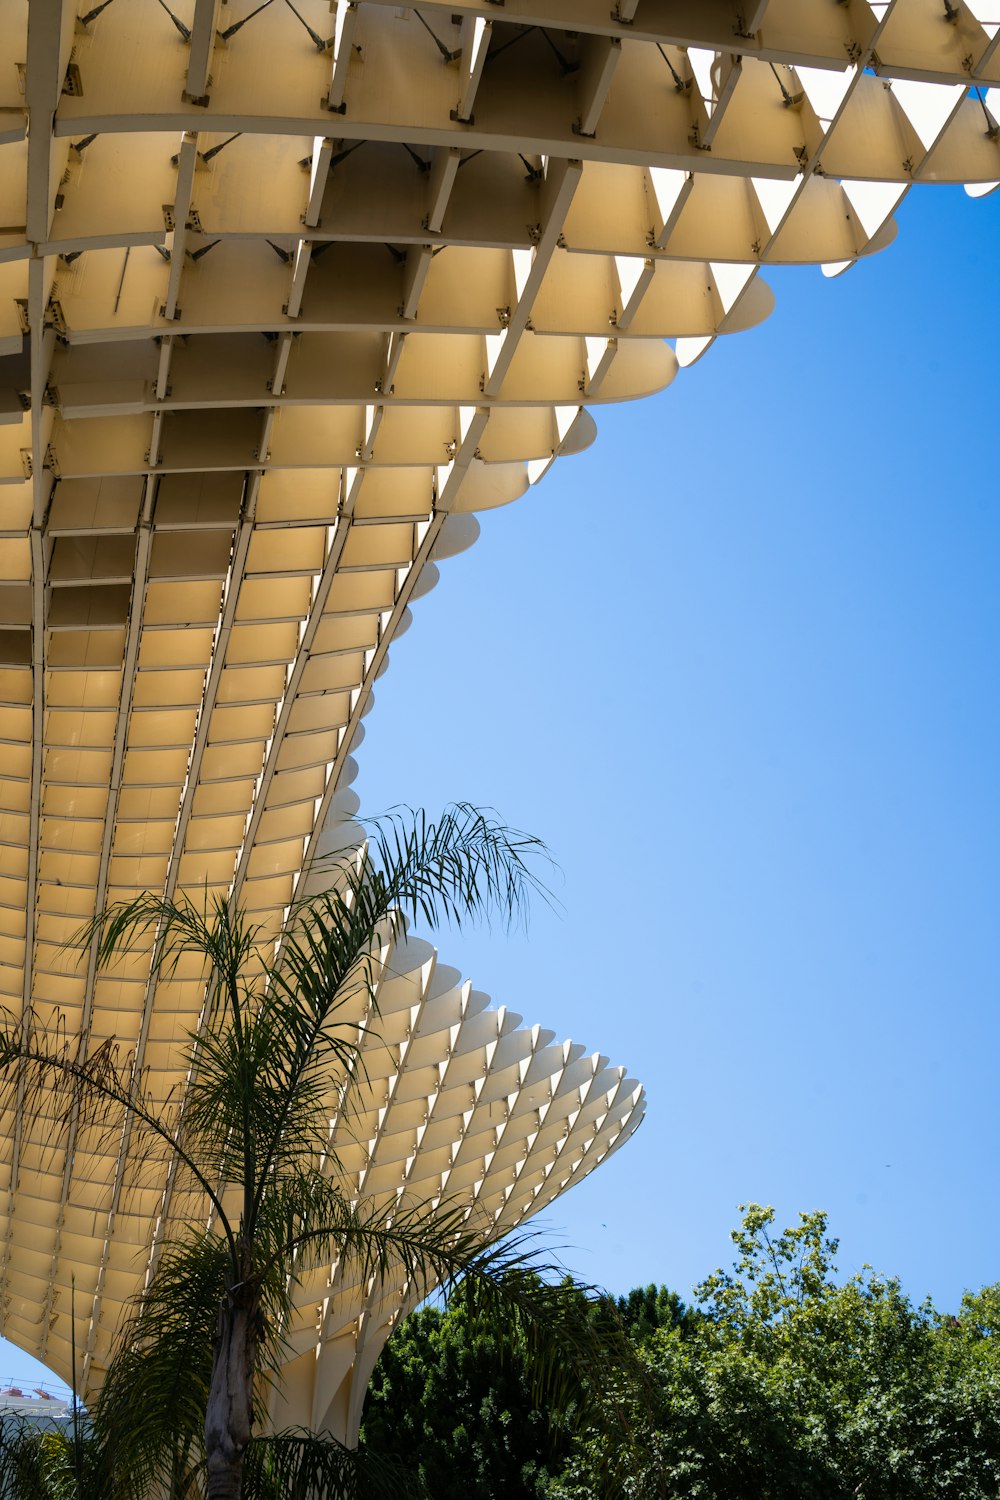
[205,1284,259,1500]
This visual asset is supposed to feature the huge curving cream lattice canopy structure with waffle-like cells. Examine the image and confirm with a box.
[0,0,1000,1437]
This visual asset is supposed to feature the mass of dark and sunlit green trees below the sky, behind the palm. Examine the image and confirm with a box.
[364,1205,1000,1500]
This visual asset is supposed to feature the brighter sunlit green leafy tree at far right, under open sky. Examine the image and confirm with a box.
[552,1205,1000,1500]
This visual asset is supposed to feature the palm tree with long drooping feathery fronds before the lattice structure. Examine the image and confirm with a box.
[0,804,632,1500]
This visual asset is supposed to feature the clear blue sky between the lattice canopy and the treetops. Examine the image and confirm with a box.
[0,188,1000,1374]
